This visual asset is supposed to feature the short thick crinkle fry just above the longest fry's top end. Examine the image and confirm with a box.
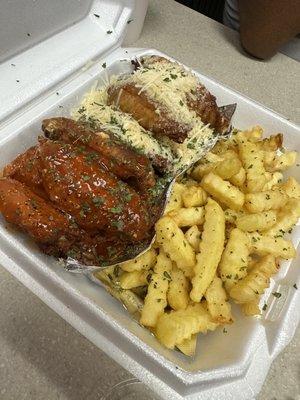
[201,172,245,211]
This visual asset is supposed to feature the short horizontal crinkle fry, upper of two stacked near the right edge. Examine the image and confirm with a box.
[245,189,288,213]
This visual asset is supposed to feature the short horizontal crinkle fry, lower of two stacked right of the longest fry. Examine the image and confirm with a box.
[236,210,276,232]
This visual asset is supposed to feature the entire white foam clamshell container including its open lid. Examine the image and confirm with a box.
[0,0,300,400]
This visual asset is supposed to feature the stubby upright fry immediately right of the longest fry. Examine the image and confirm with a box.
[219,228,250,291]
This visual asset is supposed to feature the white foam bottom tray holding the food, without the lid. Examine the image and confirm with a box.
[0,49,300,400]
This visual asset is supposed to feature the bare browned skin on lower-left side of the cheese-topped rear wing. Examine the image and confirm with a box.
[108,84,190,143]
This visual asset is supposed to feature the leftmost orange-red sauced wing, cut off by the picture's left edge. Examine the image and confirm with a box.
[0,178,97,262]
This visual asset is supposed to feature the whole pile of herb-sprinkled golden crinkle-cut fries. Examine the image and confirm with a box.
[96,127,300,356]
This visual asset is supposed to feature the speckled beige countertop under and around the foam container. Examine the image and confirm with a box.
[0,0,300,400]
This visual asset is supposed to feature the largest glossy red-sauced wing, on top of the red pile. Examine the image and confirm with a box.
[39,141,150,241]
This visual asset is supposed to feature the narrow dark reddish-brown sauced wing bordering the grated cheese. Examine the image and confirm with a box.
[42,117,155,188]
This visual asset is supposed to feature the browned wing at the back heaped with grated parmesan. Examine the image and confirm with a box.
[108,56,230,143]
